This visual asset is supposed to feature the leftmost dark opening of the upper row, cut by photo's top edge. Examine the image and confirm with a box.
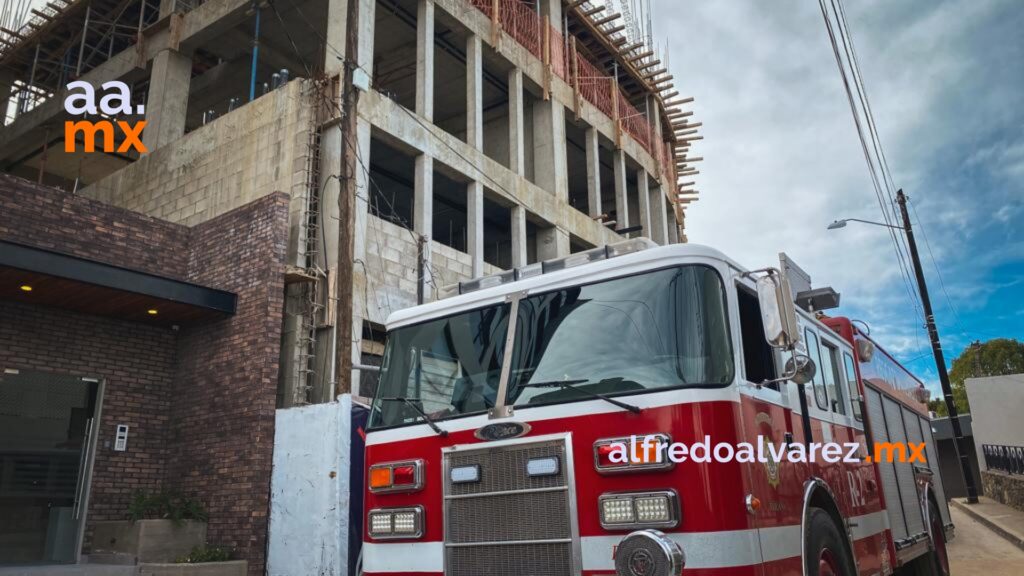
[373,0,417,110]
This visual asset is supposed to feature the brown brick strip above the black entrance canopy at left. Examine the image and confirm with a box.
[0,174,188,280]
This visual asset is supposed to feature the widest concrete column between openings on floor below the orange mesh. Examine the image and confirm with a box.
[534,99,569,202]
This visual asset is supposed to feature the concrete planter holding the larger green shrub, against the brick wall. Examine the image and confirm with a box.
[92,520,206,557]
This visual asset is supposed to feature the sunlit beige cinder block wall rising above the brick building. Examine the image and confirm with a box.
[80,79,313,259]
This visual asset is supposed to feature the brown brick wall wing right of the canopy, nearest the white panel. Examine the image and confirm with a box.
[166,194,289,575]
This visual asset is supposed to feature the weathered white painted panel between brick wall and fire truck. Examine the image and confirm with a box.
[267,395,352,576]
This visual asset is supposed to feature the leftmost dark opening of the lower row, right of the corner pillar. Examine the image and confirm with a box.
[369,138,416,230]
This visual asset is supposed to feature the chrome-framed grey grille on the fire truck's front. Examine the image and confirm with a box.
[444,440,574,576]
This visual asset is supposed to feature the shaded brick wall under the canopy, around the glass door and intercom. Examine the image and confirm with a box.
[0,300,175,545]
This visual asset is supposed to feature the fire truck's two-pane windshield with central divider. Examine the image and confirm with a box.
[370,264,733,427]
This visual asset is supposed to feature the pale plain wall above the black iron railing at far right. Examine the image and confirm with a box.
[966,374,1024,469]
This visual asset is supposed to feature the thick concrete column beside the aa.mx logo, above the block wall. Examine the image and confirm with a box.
[142,49,191,152]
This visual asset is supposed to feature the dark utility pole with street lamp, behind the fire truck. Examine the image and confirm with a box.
[896,189,978,504]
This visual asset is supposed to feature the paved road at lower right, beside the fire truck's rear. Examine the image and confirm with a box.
[947,500,1024,576]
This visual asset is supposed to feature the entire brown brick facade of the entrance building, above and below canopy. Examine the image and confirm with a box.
[0,175,289,575]
